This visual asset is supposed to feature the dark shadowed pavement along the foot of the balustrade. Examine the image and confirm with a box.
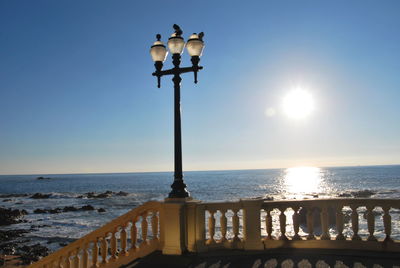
[124,249,400,268]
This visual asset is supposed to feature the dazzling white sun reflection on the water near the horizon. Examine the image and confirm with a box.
[283,167,323,195]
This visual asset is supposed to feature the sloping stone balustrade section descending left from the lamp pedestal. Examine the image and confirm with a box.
[30,202,162,268]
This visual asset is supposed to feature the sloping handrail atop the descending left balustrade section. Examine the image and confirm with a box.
[29,201,162,268]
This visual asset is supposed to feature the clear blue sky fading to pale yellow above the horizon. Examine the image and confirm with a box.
[0,0,400,174]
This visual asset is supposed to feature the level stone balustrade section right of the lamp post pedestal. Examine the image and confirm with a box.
[189,198,400,252]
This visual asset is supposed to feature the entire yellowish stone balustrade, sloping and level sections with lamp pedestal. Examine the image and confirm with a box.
[31,198,400,268]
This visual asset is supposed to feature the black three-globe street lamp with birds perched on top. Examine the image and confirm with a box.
[150,24,204,198]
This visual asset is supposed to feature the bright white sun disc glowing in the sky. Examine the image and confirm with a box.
[283,88,314,119]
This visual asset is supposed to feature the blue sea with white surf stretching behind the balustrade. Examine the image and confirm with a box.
[0,165,400,250]
